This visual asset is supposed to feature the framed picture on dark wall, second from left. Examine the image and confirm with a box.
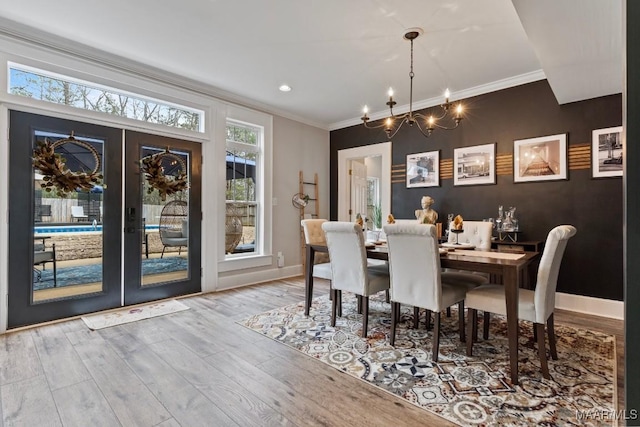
[453,143,496,185]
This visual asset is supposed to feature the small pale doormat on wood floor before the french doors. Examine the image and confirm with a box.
[82,300,189,330]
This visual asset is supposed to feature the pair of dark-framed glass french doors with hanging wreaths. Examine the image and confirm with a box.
[8,111,201,328]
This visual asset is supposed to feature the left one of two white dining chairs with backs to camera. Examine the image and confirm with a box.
[322,221,389,337]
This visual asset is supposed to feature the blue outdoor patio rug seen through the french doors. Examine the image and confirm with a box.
[33,256,188,291]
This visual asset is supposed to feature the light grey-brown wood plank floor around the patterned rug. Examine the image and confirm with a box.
[0,277,624,427]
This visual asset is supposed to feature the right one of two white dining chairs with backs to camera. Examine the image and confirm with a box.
[384,224,468,361]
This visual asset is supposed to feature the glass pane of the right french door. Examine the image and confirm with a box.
[140,146,190,287]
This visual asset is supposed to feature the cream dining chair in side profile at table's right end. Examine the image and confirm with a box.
[465,225,576,379]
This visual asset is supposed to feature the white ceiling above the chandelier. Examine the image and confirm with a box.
[0,0,623,129]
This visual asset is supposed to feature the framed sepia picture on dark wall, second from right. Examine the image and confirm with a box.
[513,133,567,182]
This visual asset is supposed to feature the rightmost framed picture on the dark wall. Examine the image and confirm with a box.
[591,126,622,178]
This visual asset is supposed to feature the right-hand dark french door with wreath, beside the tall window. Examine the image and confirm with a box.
[124,131,202,305]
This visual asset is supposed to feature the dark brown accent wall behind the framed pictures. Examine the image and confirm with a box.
[330,80,623,300]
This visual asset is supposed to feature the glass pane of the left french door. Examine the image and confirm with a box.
[32,131,104,302]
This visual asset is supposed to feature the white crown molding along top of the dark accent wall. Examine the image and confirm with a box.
[329,70,547,130]
